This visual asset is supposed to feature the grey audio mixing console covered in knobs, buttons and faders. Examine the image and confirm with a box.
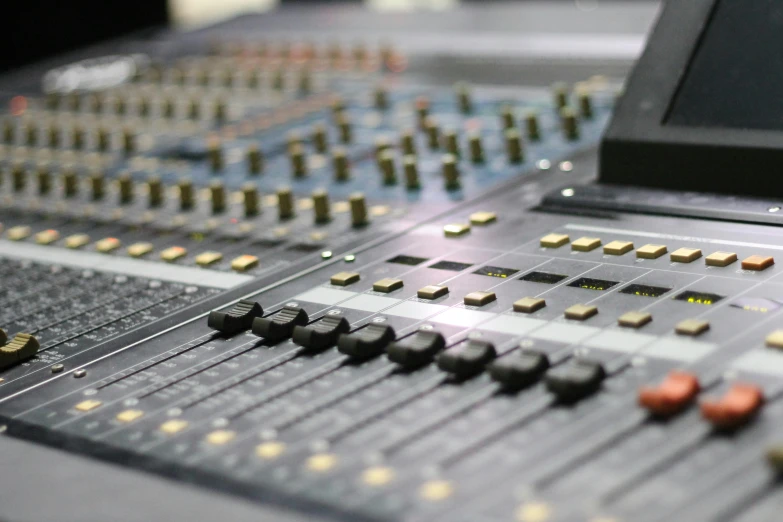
[0,0,783,522]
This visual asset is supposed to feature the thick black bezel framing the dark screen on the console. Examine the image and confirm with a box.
[600,0,783,197]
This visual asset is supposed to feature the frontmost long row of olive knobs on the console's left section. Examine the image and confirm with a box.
[0,166,368,226]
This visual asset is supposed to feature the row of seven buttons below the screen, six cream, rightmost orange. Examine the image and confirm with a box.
[540,234,775,271]
